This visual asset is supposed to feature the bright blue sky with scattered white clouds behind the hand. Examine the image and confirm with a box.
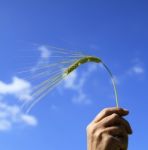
[0,0,148,150]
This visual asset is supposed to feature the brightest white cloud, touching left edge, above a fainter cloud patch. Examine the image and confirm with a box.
[0,77,32,101]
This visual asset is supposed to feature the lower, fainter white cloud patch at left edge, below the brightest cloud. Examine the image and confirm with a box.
[0,101,37,131]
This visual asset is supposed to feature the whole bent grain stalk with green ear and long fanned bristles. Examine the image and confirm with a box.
[20,47,119,113]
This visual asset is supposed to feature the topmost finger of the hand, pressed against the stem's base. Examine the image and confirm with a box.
[94,107,129,122]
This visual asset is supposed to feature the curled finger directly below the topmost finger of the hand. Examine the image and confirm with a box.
[96,113,132,134]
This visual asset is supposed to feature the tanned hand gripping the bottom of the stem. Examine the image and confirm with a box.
[87,108,132,150]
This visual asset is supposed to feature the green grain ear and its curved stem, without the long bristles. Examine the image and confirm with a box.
[64,56,119,108]
